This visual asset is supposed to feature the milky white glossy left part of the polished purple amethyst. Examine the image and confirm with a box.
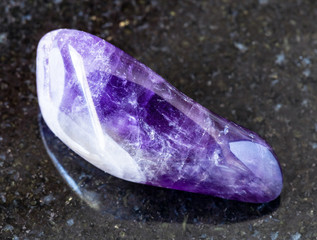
[37,31,146,183]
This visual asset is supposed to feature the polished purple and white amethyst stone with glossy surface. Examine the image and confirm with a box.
[36,29,283,203]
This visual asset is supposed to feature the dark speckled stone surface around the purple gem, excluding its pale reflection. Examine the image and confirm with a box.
[0,0,317,240]
